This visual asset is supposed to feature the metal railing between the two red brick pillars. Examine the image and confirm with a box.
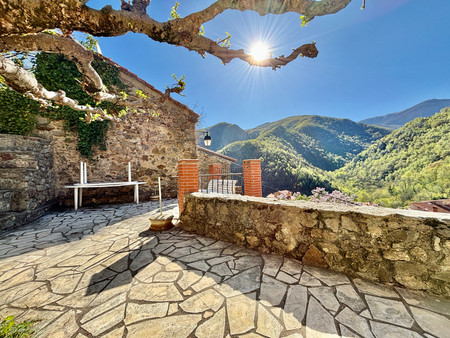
[198,173,243,195]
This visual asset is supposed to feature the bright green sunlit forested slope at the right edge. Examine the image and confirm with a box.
[332,108,450,207]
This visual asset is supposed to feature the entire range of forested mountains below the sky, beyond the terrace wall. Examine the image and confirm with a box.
[198,100,450,202]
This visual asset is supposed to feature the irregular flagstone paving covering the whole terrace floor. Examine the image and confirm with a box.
[0,200,450,338]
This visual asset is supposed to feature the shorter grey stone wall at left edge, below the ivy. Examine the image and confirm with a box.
[0,134,55,229]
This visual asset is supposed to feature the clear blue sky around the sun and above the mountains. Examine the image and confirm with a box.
[88,0,450,129]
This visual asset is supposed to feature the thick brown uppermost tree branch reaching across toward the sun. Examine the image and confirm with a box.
[0,0,351,68]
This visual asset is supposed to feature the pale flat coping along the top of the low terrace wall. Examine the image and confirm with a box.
[192,192,450,223]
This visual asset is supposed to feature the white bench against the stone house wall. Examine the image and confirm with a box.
[64,162,147,210]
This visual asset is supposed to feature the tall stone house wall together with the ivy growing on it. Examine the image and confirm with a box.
[0,54,198,205]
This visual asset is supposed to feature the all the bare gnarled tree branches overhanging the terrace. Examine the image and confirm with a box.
[0,0,351,119]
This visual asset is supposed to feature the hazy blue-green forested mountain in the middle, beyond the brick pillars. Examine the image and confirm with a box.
[220,116,389,195]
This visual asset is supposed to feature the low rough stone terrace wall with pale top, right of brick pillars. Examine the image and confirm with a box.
[181,193,450,297]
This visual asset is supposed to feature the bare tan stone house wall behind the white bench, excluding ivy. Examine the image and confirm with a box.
[36,62,198,206]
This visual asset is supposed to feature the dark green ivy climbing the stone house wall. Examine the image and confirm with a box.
[0,53,126,158]
